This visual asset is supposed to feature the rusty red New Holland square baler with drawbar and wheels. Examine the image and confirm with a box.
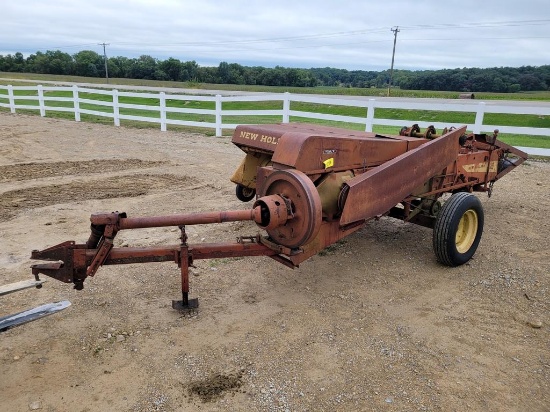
[31,123,527,310]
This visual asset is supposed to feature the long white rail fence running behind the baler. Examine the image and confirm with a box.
[0,85,550,142]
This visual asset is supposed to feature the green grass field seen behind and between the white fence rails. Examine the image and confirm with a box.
[0,72,550,148]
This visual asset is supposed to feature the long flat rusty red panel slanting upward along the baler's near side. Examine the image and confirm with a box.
[340,126,466,226]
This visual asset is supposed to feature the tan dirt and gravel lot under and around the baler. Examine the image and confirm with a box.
[0,113,550,411]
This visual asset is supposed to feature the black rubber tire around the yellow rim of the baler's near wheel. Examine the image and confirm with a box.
[433,192,484,266]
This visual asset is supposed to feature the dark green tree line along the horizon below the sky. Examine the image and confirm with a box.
[0,50,550,93]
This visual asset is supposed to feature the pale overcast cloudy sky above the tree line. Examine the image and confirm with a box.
[4,0,550,70]
